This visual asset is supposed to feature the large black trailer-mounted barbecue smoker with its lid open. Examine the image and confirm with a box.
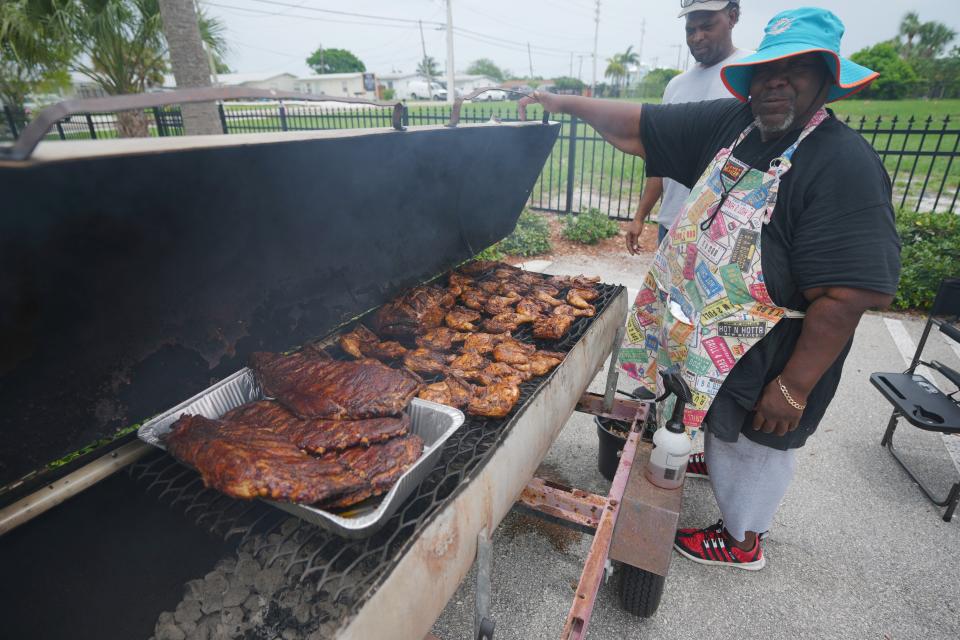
[0,90,681,640]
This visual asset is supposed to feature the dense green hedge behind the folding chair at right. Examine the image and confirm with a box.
[892,211,960,309]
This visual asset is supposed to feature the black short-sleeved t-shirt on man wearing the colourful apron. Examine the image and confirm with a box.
[640,99,900,449]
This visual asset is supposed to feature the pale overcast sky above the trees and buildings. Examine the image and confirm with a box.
[200,0,960,83]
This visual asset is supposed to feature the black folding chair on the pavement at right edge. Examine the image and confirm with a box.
[870,278,960,522]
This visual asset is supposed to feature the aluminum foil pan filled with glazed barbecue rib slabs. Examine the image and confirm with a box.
[138,368,464,538]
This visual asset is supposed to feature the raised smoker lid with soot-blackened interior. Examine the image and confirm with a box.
[0,112,559,504]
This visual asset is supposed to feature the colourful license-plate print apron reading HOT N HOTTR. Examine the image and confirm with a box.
[619,108,828,435]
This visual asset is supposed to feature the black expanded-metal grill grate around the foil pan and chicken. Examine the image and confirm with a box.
[131,284,623,631]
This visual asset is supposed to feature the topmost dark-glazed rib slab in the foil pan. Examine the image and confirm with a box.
[251,351,421,419]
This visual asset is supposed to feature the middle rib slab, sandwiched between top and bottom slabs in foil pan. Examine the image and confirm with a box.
[221,400,410,455]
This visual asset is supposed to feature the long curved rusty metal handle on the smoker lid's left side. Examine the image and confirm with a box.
[0,87,404,160]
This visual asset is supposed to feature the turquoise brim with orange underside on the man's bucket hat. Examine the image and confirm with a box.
[720,43,880,102]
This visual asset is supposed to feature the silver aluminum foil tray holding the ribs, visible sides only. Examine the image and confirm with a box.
[137,368,464,538]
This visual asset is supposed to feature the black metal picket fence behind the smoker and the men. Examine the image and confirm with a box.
[0,102,960,215]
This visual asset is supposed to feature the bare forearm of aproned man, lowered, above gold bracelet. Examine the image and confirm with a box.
[781,289,890,398]
